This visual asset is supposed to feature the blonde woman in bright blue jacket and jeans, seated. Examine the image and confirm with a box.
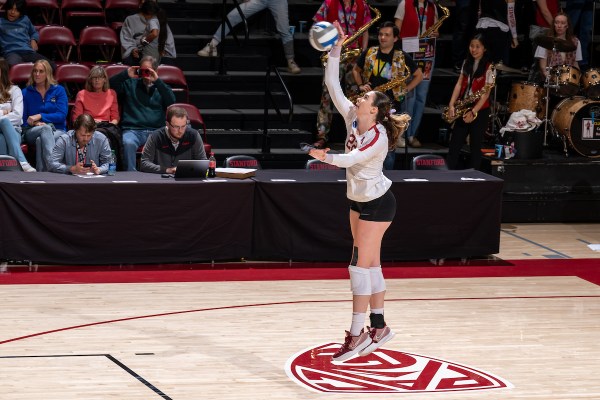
[23,60,69,171]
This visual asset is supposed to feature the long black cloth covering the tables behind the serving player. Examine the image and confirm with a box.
[0,170,502,264]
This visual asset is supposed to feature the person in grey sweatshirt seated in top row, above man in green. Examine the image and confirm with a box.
[120,0,160,65]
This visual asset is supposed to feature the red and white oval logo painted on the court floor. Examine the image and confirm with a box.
[285,343,513,393]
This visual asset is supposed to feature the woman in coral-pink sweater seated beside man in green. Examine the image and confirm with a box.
[72,65,123,171]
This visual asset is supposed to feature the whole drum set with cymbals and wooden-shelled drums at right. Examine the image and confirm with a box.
[492,36,600,158]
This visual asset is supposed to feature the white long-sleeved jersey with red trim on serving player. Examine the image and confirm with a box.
[325,47,392,202]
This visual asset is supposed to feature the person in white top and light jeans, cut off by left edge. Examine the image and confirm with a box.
[0,58,35,172]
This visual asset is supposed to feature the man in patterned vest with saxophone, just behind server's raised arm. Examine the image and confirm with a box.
[352,21,423,169]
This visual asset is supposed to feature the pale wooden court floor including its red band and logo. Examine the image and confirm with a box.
[0,224,600,400]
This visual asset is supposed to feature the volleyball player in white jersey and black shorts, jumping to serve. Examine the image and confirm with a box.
[309,21,410,361]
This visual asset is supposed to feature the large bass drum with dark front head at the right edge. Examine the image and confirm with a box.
[552,96,600,158]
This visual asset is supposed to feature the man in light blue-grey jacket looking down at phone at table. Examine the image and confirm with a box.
[50,114,111,175]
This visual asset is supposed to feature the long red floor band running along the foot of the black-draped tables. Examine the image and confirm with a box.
[0,259,600,285]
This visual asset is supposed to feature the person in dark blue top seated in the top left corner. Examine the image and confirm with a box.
[0,0,56,70]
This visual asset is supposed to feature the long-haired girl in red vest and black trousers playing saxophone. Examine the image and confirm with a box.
[447,34,495,169]
